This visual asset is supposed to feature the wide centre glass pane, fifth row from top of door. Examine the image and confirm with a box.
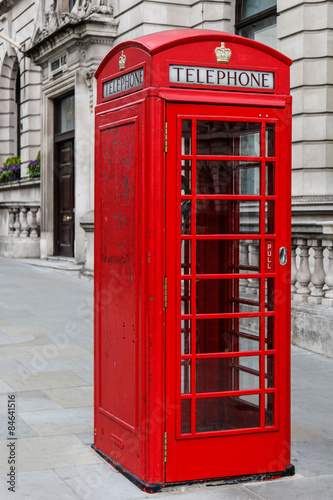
[196,278,260,314]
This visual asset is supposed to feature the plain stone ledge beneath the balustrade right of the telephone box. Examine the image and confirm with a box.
[291,301,333,358]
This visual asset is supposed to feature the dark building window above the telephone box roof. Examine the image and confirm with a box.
[235,0,277,49]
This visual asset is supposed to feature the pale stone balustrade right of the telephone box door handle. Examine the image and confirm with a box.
[291,221,333,306]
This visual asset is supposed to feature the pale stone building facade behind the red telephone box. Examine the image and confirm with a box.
[0,0,333,355]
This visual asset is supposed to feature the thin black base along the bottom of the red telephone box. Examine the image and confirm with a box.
[91,444,295,493]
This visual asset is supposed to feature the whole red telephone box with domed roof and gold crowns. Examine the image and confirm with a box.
[94,30,293,492]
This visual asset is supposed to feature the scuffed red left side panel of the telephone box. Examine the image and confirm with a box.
[95,103,143,475]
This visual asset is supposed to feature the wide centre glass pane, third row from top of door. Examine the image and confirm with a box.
[196,200,260,234]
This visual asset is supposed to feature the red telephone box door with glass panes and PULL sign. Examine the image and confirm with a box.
[166,103,290,482]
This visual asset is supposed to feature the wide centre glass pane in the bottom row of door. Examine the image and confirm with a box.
[196,396,260,432]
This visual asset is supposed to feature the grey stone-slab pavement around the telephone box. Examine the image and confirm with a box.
[0,258,333,500]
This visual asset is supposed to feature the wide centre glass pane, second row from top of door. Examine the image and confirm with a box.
[197,160,260,195]
